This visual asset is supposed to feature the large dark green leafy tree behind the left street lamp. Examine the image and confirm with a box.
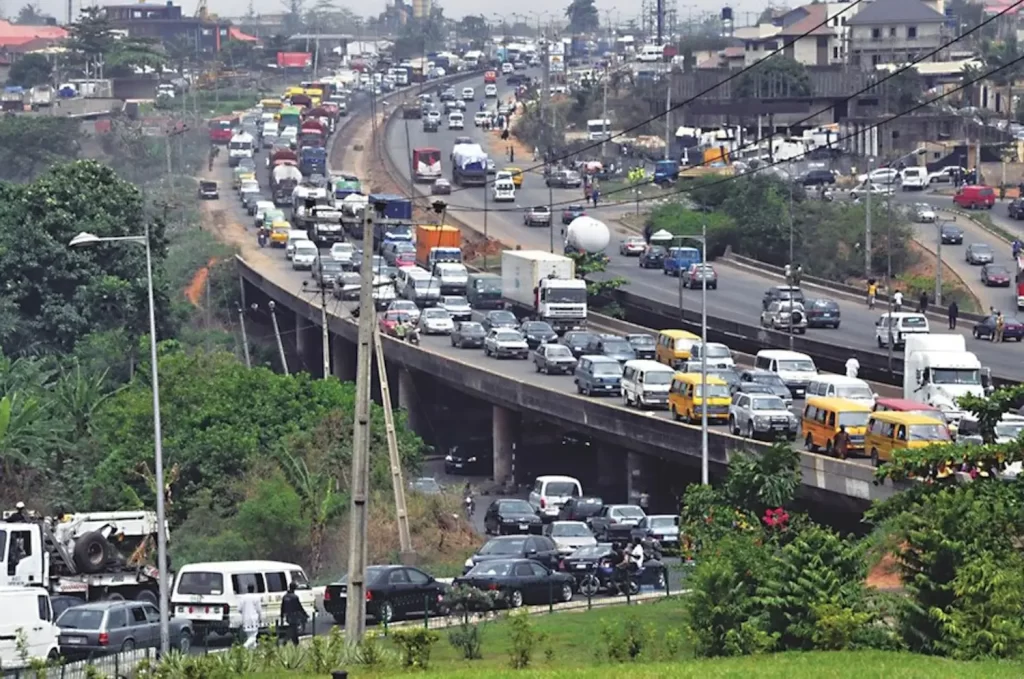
[0,161,170,355]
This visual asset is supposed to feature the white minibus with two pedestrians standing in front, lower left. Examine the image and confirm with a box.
[171,561,316,638]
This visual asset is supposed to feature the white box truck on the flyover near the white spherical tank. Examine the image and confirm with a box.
[502,250,587,333]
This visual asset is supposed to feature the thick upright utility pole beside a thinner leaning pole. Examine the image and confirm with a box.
[345,205,376,644]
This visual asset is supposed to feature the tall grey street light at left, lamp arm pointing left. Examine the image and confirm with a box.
[69,224,171,655]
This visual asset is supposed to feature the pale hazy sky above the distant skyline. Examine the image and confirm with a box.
[29,0,770,26]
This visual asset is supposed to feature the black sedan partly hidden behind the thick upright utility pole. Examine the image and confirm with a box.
[324,565,447,625]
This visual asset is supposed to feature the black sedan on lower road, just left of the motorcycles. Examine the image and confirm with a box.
[453,559,575,608]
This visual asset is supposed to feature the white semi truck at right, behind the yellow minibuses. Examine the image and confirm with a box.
[903,334,987,426]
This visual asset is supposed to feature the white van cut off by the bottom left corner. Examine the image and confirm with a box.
[0,585,60,670]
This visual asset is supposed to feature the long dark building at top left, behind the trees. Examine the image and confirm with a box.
[102,0,256,52]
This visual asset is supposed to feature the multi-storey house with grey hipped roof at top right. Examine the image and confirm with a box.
[848,0,946,70]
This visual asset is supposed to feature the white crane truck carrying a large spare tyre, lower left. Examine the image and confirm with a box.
[0,511,160,604]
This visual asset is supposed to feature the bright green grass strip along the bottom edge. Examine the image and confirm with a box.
[245,650,1024,679]
